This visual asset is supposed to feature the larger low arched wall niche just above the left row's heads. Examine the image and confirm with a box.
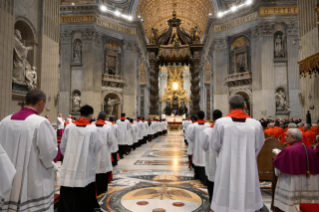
[102,91,123,120]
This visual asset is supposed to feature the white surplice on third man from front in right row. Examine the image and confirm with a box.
[188,123,209,167]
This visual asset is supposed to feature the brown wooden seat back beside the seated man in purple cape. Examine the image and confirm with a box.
[257,137,285,181]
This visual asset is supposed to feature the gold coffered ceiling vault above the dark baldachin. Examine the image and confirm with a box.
[136,0,213,40]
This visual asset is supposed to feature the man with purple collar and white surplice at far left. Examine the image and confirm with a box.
[0,89,58,212]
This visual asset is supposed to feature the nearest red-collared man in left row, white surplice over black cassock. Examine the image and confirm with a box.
[58,105,104,212]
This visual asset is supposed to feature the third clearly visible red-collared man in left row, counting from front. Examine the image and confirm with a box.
[116,113,132,159]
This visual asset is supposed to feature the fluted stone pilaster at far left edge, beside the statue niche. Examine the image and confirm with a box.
[0,0,15,119]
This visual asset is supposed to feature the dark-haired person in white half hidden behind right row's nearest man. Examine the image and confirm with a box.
[200,110,222,202]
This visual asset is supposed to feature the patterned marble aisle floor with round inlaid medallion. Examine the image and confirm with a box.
[56,131,271,212]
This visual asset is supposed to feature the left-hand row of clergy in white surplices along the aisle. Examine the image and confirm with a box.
[0,89,167,212]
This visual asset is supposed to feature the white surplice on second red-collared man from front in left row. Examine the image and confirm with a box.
[95,124,114,174]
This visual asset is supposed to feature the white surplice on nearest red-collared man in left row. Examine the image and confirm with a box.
[58,125,104,187]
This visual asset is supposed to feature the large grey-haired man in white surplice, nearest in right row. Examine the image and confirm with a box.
[210,95,265,212]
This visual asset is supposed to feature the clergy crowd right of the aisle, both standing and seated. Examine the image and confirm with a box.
[183,95,319,212]
